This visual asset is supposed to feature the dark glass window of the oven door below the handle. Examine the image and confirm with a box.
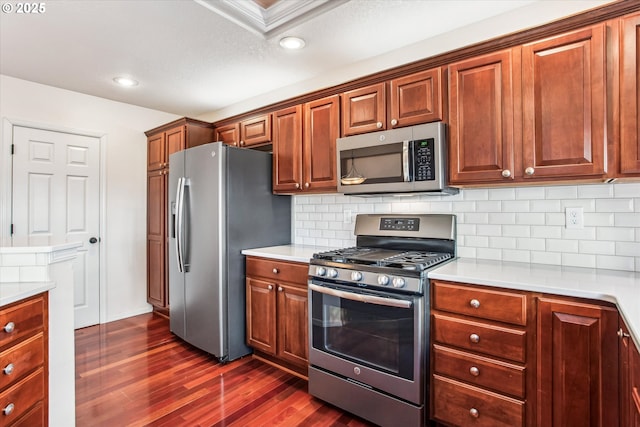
[311,292,415,380]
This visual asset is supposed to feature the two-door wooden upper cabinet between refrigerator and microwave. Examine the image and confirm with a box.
[273,95,340,194]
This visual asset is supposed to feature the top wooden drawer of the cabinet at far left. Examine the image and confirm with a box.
[0,296,45,347]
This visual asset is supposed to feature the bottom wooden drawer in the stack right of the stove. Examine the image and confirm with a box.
[432,375,525,427]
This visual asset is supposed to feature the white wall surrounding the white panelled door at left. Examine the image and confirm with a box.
[0,75,179,322]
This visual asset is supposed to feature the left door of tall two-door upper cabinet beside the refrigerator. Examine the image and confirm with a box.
[273,105,302,192]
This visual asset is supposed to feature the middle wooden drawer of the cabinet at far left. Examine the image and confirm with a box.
[0,332,44,389]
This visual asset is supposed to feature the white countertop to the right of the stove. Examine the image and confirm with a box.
[429,258,640,347]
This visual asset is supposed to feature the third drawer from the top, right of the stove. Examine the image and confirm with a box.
[433,345,525,398]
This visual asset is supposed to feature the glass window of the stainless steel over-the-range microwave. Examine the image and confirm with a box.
[340,142,404,184]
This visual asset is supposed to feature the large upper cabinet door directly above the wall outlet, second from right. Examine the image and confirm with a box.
[518,24,606,179]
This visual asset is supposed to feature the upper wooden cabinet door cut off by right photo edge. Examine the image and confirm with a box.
[620,15,640,174]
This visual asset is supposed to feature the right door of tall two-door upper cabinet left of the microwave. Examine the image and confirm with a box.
[302,95,340,191]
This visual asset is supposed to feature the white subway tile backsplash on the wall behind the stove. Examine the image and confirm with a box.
[294,182,640,272]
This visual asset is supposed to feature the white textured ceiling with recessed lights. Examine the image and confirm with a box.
[0,0,608,117]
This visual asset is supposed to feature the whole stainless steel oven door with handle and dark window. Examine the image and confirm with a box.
[309,280,426,405]
